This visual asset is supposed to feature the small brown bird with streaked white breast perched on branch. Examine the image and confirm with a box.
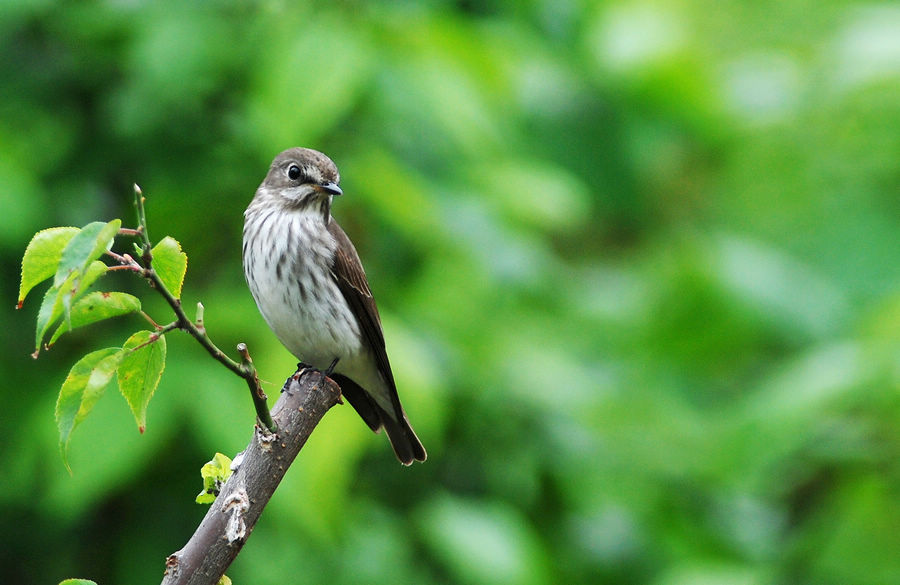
[242,147,427,465]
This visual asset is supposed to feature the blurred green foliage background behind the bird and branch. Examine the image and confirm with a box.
[0,0,900,585]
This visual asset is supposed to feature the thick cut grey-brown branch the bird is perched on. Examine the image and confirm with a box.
[162,370,341,585]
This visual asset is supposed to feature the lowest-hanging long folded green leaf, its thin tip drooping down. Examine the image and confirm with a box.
[56,347,123,469]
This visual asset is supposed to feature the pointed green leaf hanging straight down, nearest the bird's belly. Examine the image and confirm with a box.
[118,331,166,433]
